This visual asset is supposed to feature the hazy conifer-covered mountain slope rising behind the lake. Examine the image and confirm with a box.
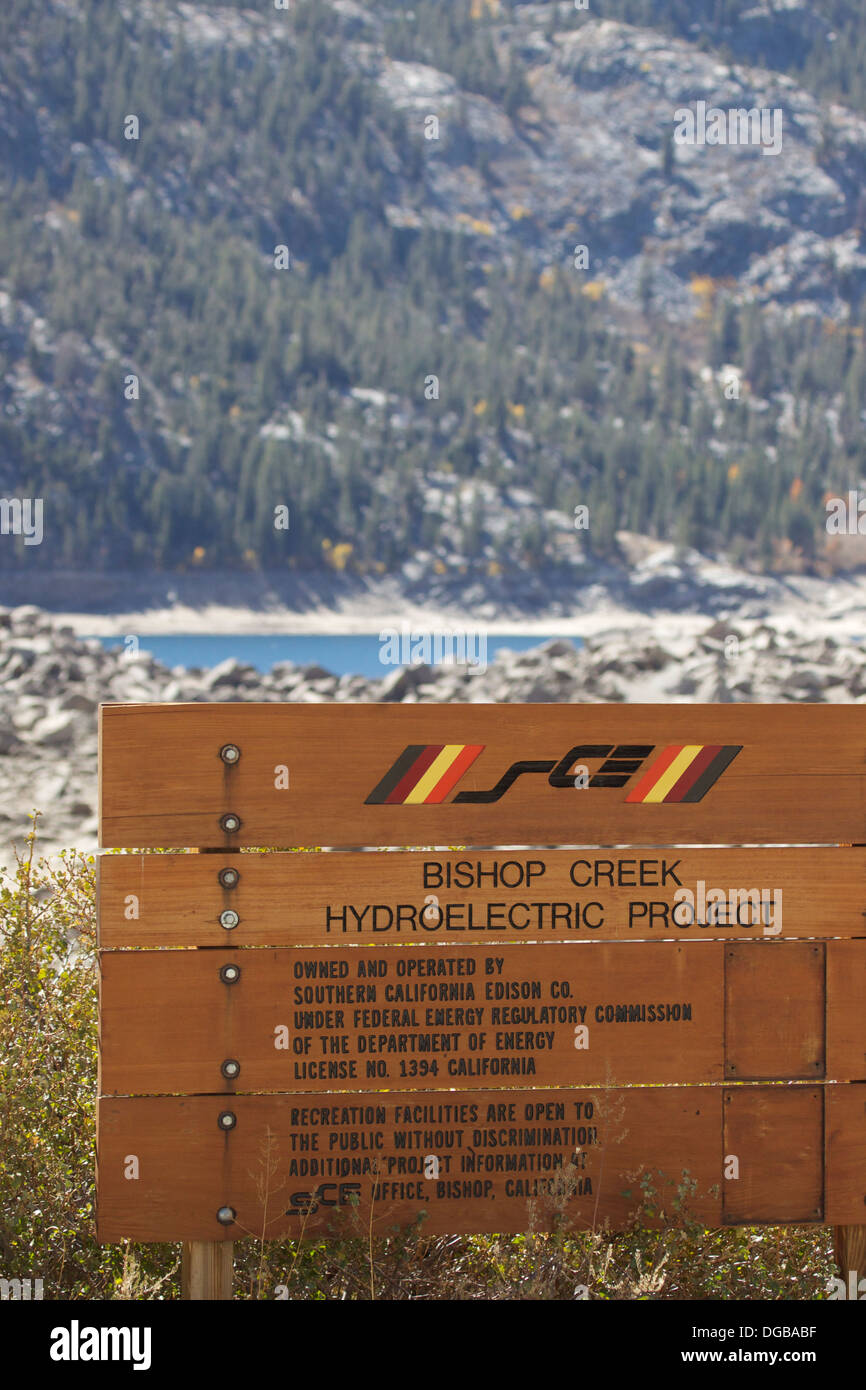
[0,0,866,581]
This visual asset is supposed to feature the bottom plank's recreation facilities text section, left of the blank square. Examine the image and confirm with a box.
[97,1087,721,1243]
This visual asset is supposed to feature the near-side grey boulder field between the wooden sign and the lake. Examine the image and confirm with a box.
[0,606,866,869]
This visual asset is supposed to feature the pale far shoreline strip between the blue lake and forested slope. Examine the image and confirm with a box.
[10,542,866,637]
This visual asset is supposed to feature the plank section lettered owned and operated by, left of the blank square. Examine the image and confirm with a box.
[101,941,728,1095]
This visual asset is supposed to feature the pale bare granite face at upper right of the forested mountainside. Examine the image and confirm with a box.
[375,6,866,321]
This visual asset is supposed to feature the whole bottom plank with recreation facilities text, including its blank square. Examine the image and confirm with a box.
[97,1086,866,1241]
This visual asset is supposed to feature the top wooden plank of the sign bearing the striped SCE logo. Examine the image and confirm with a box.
[100,703,866,848]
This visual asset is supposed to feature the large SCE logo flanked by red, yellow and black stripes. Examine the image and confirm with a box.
[364,744,742,806]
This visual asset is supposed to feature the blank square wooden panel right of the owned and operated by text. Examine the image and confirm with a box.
[724,941,828,1081]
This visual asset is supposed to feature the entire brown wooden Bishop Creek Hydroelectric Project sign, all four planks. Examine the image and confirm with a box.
[97,705,866,1241]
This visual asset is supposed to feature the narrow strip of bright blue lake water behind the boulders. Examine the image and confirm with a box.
[94,632,581,678]
